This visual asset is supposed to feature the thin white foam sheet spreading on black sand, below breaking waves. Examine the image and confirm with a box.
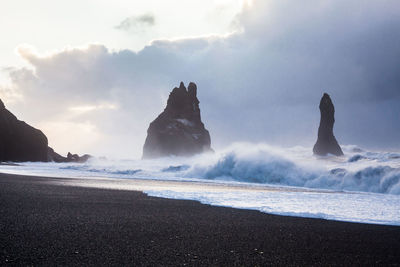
[145,190,400,225]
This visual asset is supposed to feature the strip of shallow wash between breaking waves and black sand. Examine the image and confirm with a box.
[0,172,400,226]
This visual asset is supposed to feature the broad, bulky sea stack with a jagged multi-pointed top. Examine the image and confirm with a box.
[143,82,212,158]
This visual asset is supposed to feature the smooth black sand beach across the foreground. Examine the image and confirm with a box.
[0,174,400,266]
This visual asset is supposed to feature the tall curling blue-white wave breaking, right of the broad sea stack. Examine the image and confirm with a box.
[186,145,400,195]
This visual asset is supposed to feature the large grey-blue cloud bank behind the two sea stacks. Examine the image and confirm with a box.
[0,0,400,157]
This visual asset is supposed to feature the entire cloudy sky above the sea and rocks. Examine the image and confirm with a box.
[0,0,400,158]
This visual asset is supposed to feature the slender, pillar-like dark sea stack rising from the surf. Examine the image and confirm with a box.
[313,93,343,156]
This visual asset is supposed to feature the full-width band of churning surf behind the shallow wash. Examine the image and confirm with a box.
[2,143,400,195]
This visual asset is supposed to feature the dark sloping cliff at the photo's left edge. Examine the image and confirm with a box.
[0,100,47,162]
